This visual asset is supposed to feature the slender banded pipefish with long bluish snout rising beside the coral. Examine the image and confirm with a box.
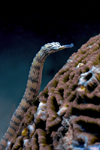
[0,42,73,150]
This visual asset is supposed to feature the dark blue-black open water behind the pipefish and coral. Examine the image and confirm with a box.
[0,1,100,139]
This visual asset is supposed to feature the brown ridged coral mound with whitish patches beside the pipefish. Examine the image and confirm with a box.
[6,35,100,150]
